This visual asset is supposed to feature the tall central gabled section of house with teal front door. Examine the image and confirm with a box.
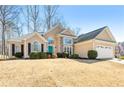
[45,24,76,55]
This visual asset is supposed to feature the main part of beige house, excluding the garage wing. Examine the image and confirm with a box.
[0,24,76,58]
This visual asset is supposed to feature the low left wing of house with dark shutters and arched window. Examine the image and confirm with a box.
[7,32,47,58]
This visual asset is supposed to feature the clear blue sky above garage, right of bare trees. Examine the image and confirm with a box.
[59,5,124,42]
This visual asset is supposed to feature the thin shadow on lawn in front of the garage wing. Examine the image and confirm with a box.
[72,58,110,64]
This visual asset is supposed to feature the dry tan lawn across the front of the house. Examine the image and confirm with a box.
[0,59,124,87]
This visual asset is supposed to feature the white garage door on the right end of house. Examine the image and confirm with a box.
[96,45,114,59]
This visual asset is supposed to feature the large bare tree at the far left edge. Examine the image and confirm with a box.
[0,5,18,58]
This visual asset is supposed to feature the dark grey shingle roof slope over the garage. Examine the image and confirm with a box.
[75,26,107,43]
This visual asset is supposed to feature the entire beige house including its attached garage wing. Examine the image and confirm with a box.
[0,24,116,59]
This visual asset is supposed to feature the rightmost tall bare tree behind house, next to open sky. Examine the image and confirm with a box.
[43,5,59,30]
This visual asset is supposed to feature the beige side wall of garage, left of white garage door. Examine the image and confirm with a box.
[74,40,93,58]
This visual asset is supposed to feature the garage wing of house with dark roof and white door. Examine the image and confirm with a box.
[74,26,116,59]
